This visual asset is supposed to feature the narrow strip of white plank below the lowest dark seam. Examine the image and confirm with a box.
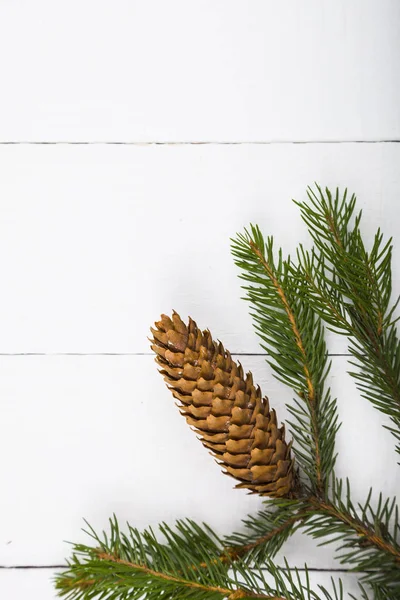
[0,569,358,600]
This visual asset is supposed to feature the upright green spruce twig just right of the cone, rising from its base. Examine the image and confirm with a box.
[232,226,339,497]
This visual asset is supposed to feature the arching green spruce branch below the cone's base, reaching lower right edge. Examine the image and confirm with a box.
[225,478,400,593]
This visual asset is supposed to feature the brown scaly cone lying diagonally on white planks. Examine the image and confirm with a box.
[151,312,294,497]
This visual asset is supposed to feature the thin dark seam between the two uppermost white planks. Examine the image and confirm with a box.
[0,139,400,146]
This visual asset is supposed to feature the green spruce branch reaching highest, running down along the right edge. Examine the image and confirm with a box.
[296,186,400,452]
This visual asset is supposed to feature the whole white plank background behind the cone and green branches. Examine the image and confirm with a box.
[0,0,400,600]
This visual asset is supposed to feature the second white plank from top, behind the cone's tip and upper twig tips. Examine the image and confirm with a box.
[0,144,400,353]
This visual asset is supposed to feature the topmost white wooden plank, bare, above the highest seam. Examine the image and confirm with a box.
[0,0,400,141]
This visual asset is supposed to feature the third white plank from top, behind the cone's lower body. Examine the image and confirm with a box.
[0,356,400,568]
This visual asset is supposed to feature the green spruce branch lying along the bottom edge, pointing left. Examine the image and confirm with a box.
[56,517,342,600]
